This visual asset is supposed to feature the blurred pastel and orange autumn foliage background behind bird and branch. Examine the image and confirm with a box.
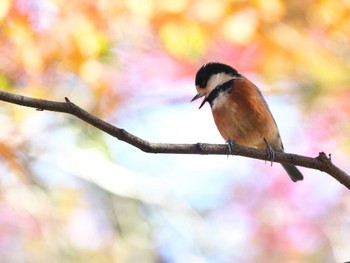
[0,0,350,263]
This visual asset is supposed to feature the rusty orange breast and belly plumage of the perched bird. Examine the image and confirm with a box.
[212,79,282,150]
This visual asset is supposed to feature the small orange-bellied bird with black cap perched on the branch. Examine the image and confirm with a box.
[191,63,303,182]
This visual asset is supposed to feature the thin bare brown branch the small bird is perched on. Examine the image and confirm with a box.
[0,91,350,189]
